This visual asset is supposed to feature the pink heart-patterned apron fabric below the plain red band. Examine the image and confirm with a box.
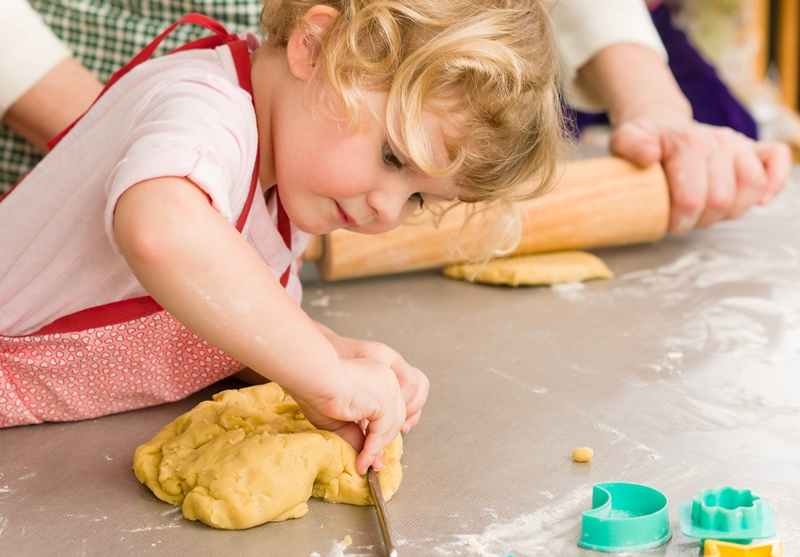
[0,311,244,427]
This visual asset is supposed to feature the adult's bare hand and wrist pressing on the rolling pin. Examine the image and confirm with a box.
[578,44,791,234]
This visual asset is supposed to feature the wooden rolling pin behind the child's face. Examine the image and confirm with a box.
[305,157,669,280]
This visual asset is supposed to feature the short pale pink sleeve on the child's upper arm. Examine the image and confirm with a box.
[105,71,258,249]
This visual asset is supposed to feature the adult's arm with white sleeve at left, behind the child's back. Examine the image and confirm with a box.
[0,0,102,151]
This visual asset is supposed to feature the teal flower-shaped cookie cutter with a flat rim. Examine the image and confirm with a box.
[678,486,775,544]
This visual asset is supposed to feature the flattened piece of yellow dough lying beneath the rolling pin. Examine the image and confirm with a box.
[442,251,614,286]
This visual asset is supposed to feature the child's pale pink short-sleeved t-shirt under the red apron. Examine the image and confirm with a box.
[0,38,308,336]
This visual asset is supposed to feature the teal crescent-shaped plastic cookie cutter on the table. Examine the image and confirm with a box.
[578,482,672,552]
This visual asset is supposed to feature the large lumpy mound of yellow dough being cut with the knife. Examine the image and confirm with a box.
[133,383,403,530]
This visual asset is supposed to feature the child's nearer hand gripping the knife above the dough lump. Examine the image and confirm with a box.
[291,358,406,474]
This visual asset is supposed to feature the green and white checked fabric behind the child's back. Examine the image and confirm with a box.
[0,0,261,194]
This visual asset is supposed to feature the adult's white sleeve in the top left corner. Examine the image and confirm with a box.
[0,0,71,116]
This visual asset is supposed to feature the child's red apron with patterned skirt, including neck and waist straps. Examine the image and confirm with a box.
[0,14,291,427]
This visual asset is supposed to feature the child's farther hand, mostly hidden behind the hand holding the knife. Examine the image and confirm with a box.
[317,323,430,433]
